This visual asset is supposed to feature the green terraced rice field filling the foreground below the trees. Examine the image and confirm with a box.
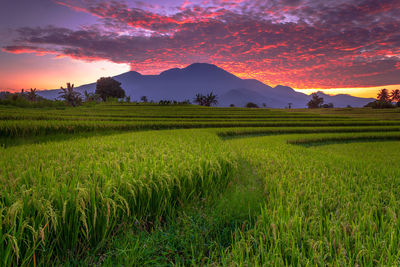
[0,104,400,266]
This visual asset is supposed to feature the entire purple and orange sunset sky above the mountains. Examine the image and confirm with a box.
[0,0,400,97]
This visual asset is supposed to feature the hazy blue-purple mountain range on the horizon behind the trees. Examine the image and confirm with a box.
[38,63,375,108]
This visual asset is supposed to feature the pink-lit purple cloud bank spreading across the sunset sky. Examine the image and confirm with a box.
[4,0,400,88]
